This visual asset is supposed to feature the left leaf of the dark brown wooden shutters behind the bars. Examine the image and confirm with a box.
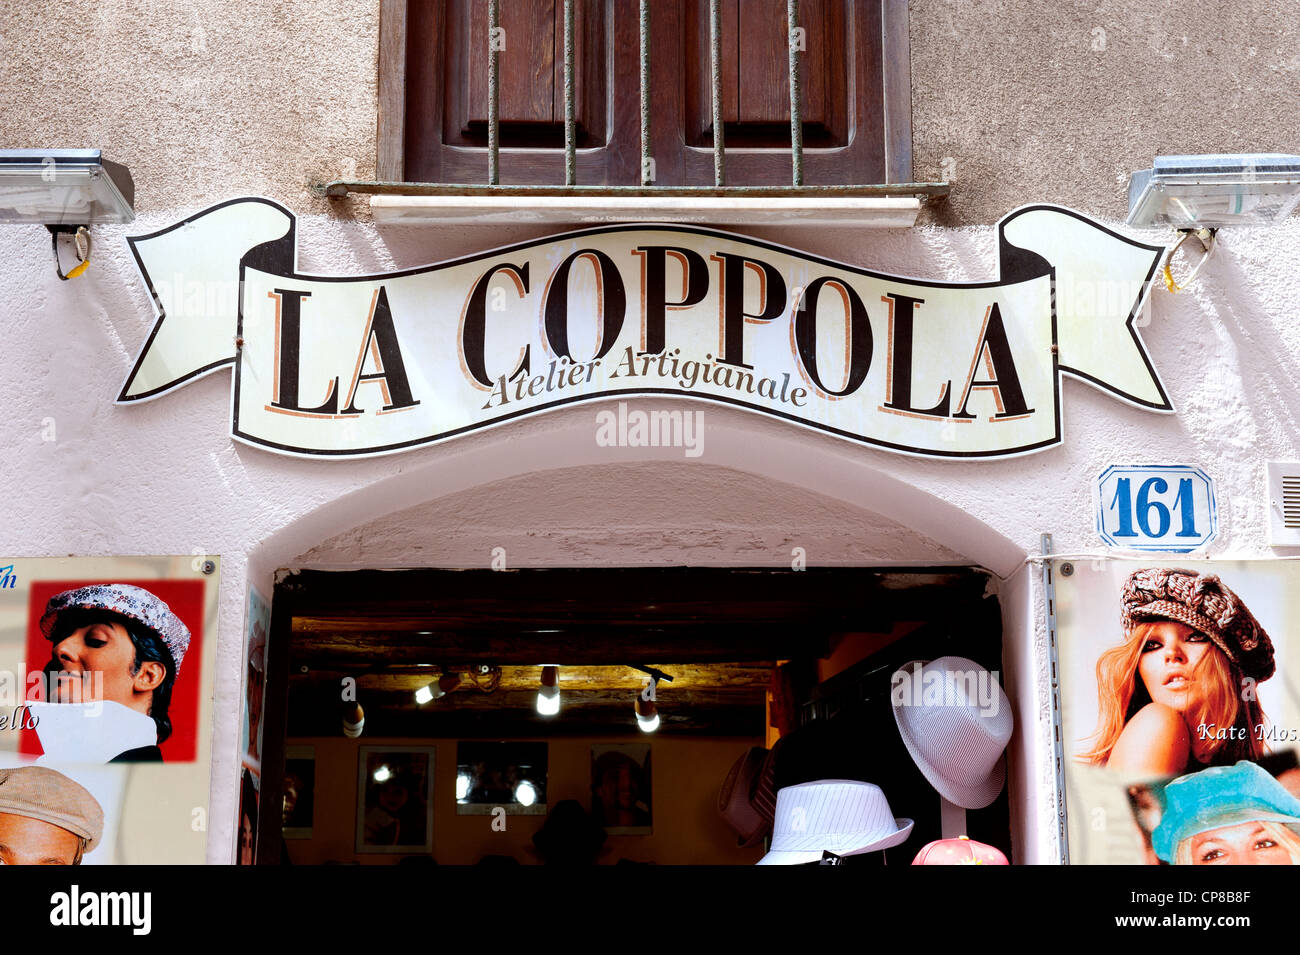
[397,0,638,186]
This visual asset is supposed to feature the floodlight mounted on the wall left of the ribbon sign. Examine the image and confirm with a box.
[0,149,135,279]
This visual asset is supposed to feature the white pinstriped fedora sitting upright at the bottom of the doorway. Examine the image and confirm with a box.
[758,780,911,865]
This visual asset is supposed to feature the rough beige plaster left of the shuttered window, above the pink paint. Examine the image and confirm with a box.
[0,0,380,213]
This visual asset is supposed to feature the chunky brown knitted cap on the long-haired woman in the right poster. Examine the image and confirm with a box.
[1121,568,1275,680]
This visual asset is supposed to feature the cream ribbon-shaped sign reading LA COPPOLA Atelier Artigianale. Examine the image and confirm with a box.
[118,199,1173,457]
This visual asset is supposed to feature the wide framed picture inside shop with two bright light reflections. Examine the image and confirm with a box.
[456,741,546,816]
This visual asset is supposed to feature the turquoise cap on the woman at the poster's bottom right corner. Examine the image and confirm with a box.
[1151,760,1300,863]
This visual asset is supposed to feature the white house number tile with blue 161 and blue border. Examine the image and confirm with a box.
[1096,464,1218,554]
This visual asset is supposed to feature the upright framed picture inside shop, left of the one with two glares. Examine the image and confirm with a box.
[356,746,436,854]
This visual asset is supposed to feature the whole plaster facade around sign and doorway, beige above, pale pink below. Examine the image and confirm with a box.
[0,0,1300,861]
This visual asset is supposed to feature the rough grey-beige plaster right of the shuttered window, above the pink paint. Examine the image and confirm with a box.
[909,0,1300,225]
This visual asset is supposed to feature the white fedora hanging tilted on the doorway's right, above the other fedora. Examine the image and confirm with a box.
[889,656,1015,809]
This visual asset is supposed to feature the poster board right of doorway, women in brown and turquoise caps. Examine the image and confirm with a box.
[1054,559,1300,865]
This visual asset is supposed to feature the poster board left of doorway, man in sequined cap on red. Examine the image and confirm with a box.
[0,556,218,864]
